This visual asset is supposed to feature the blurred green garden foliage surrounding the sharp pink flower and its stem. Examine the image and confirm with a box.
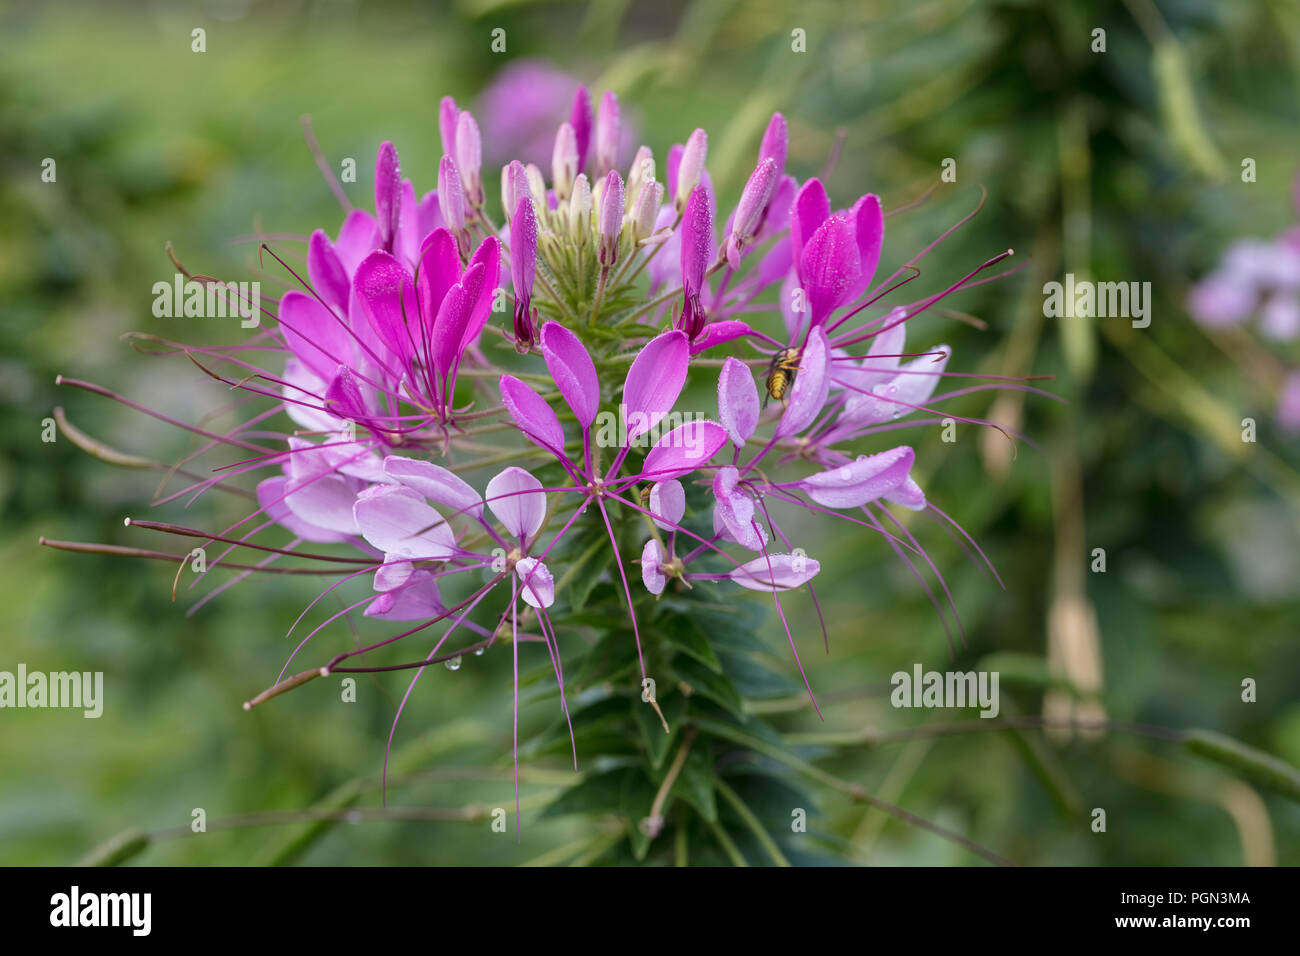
[0,0,1300,865]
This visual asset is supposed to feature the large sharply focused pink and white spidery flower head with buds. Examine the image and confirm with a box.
[50,87,1028,832]
